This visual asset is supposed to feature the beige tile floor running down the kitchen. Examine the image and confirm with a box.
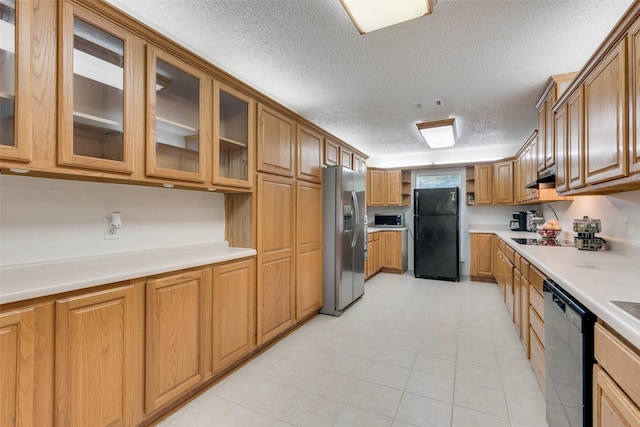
[159,272,547,427]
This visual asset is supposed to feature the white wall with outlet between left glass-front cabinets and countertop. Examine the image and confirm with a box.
[0,175,224,265]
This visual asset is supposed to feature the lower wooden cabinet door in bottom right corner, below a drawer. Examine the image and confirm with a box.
[593,365,640,427]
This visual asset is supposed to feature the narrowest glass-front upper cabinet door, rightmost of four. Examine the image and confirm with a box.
[213,82,256,188]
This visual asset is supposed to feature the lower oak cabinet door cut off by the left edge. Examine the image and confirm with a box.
[0,308,34,426]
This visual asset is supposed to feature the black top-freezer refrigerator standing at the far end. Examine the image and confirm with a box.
[413,187,460,282]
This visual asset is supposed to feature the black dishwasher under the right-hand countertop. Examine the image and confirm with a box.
[543,279,596,427]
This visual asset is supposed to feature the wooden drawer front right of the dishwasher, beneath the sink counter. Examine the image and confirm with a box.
[594,323,640,405]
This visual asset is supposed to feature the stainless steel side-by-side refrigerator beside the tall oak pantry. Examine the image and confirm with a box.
[320,166,366,316]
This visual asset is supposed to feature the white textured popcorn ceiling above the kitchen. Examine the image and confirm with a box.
[108,0,632,164]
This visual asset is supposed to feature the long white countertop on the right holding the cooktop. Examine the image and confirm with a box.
[469,228,640,348]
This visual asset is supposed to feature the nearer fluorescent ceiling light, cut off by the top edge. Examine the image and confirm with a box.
[340,0,435,34]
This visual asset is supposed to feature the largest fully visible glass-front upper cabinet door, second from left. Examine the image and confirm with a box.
[58,1,136,173]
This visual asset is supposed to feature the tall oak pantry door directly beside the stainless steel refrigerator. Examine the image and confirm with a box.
[296,181,323,320]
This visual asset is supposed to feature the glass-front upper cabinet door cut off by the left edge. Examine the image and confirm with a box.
[0,1,33,162]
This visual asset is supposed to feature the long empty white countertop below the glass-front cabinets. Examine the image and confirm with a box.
[0,241,256,304]
